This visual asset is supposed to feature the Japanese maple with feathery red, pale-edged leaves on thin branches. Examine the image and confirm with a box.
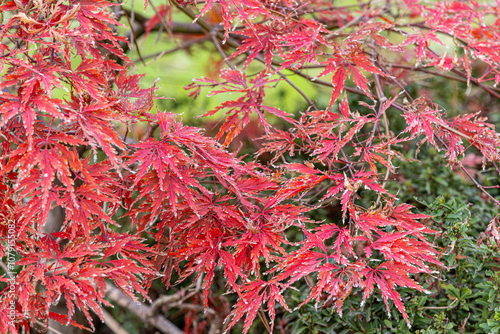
[0,0,500,333]
